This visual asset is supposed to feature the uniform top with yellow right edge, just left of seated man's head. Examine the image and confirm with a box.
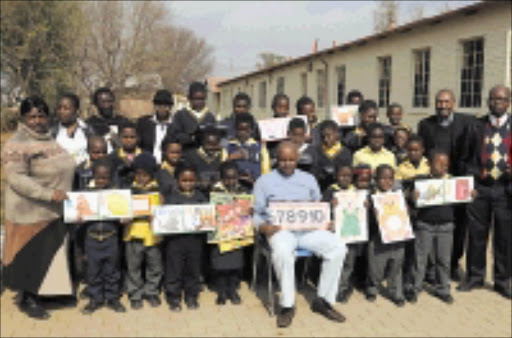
[226,138,270,180]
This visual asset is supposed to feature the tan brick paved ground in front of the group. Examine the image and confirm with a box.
[0,254,512,337]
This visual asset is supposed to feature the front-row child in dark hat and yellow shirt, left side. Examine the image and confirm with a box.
[123,152,163,310]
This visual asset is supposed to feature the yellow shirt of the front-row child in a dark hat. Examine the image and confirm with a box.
[123,180,162,246]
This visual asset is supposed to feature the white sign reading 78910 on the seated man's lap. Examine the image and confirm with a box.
[268,202,330,231]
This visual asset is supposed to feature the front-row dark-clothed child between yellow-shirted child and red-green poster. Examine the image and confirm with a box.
[164,162,208,312]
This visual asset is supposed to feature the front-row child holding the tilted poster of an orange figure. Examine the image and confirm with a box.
[366,164,405,307]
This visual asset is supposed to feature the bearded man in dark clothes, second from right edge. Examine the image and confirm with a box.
[418,89,475,281]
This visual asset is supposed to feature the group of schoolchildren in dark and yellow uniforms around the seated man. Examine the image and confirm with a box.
[68,83,464,314]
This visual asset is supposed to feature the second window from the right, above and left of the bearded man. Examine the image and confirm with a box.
[412,49,430,107]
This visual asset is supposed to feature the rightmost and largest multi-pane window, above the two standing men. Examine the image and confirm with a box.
[460,38,484,108]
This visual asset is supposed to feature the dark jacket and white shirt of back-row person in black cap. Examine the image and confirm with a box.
[137,114,172,163]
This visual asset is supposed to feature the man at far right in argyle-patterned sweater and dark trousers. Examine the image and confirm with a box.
[457,86,512,299]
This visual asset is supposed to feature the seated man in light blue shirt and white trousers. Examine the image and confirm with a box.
[253,141,346,327]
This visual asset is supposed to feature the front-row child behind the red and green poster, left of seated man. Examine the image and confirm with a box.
[210,161,248,305]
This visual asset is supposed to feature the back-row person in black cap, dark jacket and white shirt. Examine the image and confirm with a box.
[137,89,174,163]
